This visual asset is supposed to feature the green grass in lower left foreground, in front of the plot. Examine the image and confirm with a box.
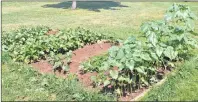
[2,54,115,101]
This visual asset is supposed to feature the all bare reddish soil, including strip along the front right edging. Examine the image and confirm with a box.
[31,42,170,101]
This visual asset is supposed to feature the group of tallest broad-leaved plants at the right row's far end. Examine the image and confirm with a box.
[141,4,198,60]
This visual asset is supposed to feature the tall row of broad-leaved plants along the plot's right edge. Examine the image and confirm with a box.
[82,4,198,96]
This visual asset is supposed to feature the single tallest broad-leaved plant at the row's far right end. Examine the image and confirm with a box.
[165,4,198,57]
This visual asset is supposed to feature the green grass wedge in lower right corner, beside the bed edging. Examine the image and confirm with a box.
[141,57,198,101]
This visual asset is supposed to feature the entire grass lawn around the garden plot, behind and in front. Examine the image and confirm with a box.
[2,2,198,100]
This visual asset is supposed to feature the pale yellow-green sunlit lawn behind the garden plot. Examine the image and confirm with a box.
[2,2,198,38]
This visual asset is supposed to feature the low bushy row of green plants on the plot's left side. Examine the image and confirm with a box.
[2,26,113,71]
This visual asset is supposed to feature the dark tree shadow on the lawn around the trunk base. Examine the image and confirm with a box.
[42,1,128,12]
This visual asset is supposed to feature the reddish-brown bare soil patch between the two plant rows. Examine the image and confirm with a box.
[32,43,111,86]
